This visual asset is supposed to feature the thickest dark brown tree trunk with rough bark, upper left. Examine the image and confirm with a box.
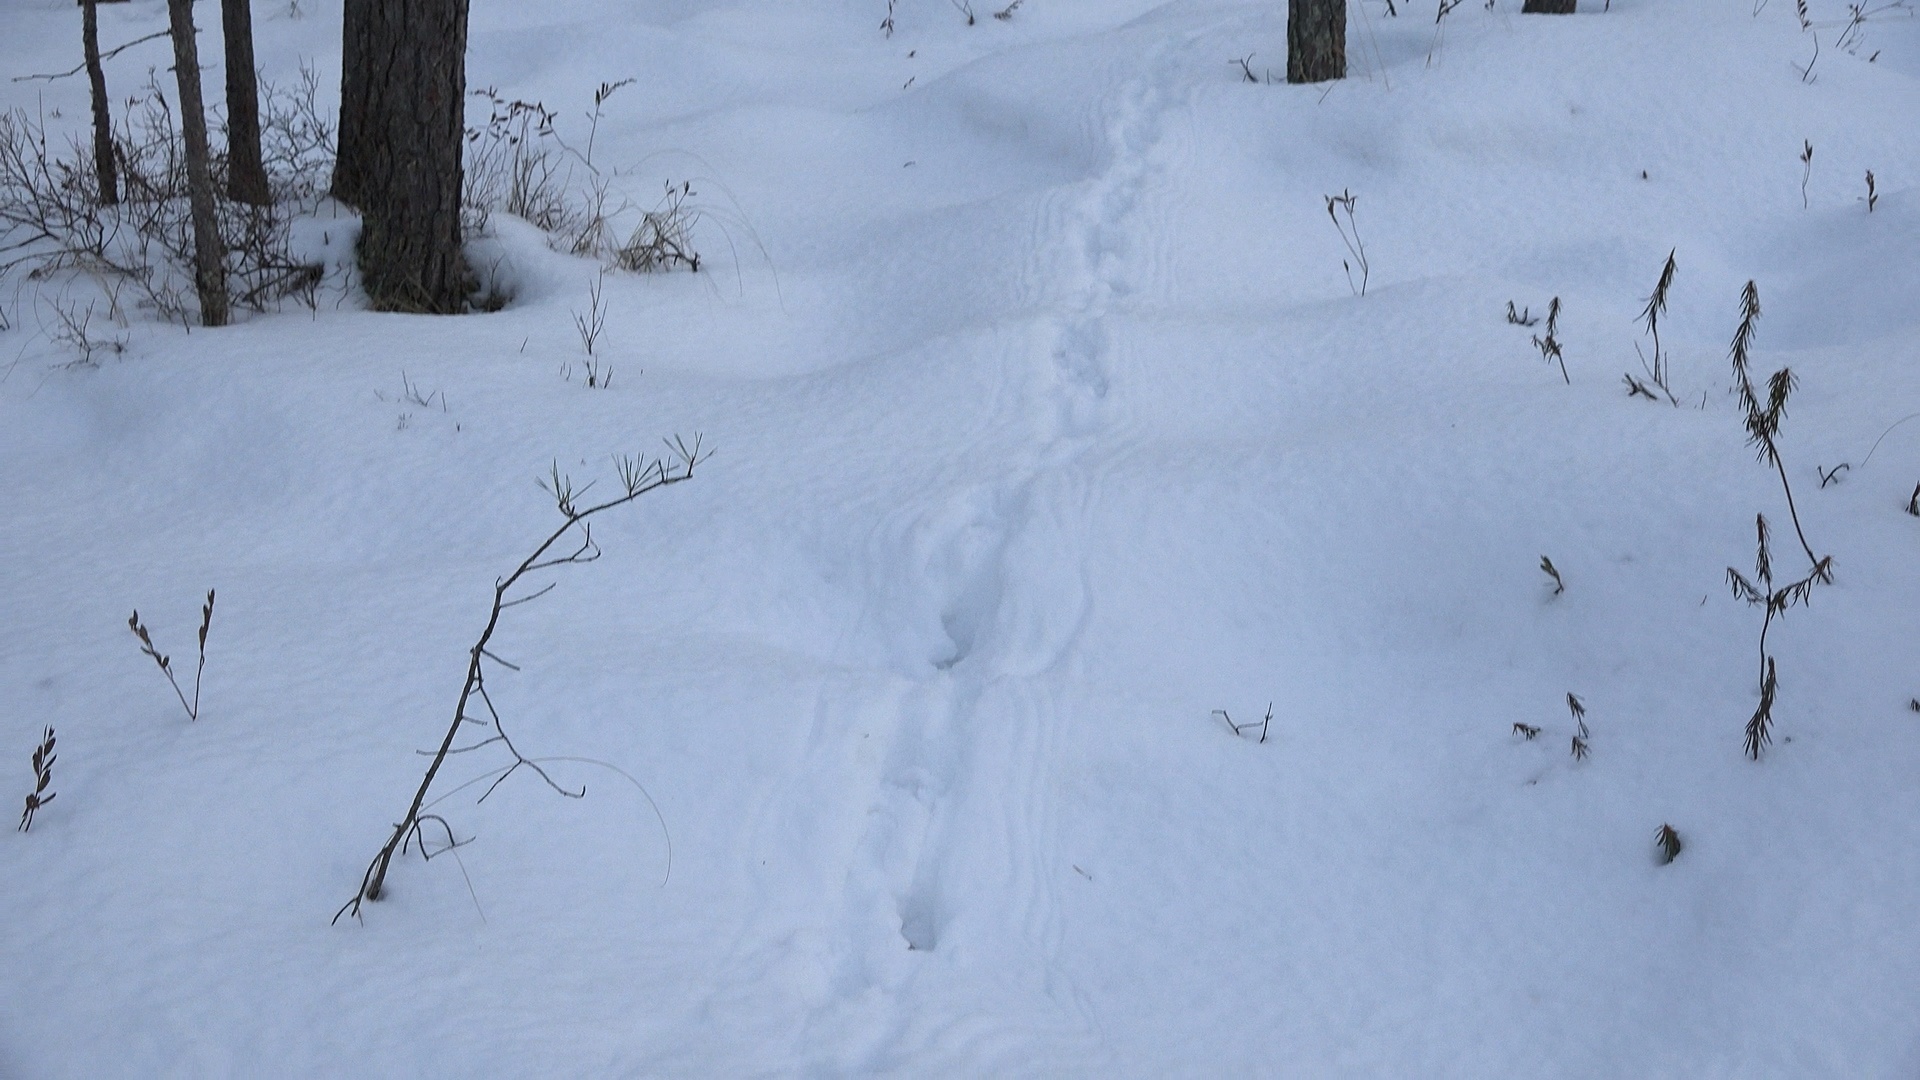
[336,0,470,315]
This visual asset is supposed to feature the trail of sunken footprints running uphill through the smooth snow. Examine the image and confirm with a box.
[794,18,1213,1068]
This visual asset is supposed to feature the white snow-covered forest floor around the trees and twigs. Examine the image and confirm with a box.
[0,0,1920,1078]
